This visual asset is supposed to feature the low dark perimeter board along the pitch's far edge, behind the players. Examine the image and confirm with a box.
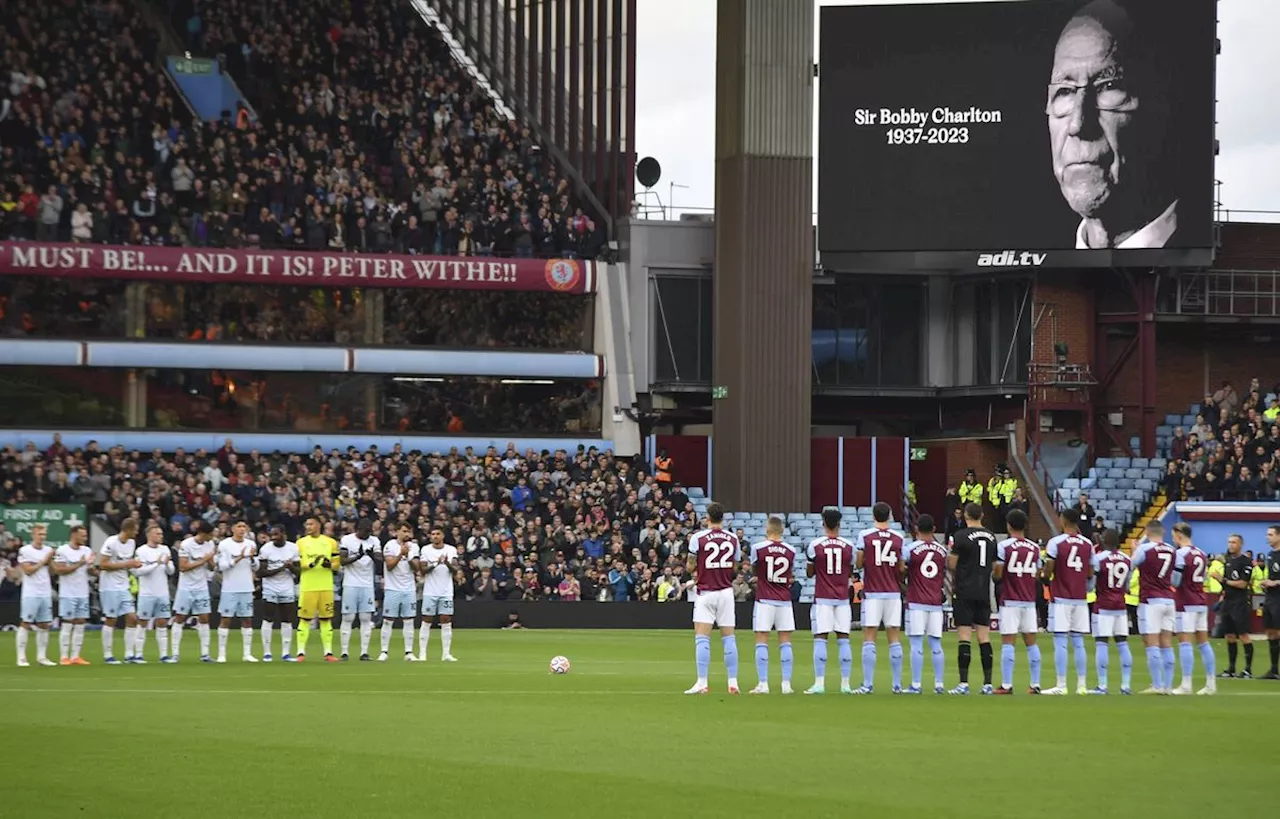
[0,600,819,631]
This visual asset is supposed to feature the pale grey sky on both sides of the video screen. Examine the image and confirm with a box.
[636,0,1280,221]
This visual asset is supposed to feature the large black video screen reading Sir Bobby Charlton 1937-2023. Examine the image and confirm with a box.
[818,0,1216,271]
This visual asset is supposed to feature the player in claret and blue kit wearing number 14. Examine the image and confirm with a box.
[854,503,906,694]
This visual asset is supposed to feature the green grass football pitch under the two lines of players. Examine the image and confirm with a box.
[0,630,1280,819]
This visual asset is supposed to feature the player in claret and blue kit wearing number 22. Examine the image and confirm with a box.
[685,503,742,694]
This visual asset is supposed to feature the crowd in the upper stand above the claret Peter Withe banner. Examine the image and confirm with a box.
[0,0,605,257]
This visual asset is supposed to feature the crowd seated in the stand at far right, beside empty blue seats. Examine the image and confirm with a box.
[1164,379,1280,500]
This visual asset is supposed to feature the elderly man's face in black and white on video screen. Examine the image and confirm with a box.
[1046,1,1157,218]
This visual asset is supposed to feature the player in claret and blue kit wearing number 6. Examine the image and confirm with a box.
[902,514,947,694]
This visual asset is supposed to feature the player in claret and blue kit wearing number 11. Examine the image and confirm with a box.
[805,508,856,694]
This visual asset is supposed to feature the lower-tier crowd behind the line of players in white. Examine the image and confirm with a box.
[0,439,711,603]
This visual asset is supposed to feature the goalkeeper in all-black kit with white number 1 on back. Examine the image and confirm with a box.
[947,503,996,694]
